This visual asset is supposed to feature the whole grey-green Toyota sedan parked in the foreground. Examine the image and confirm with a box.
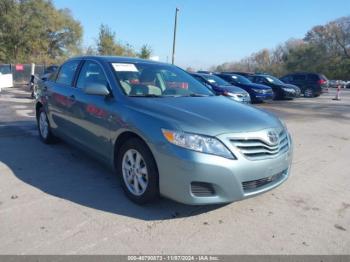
[36,56,292,205]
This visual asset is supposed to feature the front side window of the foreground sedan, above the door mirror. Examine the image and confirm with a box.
[77,61,108,88]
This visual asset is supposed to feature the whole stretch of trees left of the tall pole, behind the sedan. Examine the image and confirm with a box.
[0,0,152,64]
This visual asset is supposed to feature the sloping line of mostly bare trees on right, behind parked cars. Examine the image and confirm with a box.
[210,16,350,80]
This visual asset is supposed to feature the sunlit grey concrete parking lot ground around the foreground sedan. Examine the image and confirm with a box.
[0,87,350,254]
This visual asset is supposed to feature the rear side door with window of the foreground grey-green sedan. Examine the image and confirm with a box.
[44,60,81,138]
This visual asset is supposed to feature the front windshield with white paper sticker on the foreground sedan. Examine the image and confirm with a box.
[111,63,214,97]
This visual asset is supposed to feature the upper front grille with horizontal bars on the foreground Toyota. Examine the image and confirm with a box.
[230,130,289,160]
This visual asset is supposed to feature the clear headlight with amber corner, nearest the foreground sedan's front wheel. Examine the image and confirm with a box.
[162,129,235,159]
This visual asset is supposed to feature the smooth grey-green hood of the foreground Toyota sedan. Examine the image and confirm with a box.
[128,96,281,136]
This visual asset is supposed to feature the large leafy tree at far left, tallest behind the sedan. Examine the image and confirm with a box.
[0,0,82,63]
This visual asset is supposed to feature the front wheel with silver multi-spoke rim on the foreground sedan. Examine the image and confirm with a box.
[116,138,159,205]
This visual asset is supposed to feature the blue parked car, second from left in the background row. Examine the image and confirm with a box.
[215,73,273,103]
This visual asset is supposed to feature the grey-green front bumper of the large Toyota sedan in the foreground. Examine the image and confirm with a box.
[155,130,293,205]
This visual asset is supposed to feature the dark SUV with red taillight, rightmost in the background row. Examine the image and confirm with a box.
[280,73,328,97]
